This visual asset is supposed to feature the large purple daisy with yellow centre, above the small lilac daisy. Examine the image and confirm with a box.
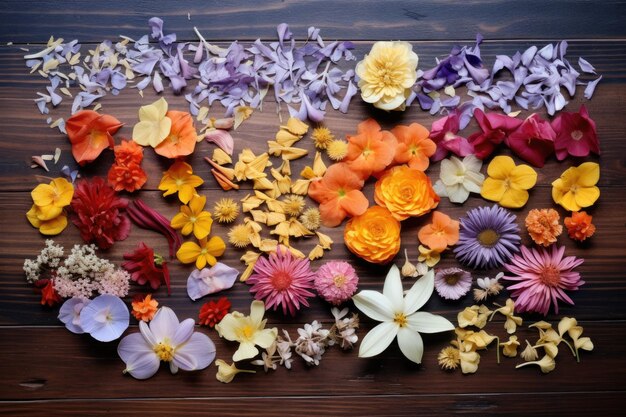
[454,206,521,269]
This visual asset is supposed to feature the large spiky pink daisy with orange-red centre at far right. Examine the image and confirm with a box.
[503,245,585,316]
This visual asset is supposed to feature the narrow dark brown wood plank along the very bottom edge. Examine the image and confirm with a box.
[0,392,624,417]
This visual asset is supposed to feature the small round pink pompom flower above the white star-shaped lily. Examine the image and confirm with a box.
[315,261,359,305]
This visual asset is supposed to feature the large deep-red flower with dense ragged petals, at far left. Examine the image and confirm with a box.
[71,177,130,249]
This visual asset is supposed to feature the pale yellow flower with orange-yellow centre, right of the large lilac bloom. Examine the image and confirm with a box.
[215,300,278,362]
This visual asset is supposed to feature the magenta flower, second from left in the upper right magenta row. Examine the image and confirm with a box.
[467,108,522,159]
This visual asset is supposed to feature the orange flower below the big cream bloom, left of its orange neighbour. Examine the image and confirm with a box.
[344,119,397,179]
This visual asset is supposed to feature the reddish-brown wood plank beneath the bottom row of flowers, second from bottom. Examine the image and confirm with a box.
[0,321,626,400]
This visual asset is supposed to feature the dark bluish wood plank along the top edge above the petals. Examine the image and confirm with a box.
[0,0,626,43]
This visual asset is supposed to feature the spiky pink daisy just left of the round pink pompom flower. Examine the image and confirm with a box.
[246,246,315,316]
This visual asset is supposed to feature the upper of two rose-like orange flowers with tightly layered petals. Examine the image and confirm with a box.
[374,165,439,220]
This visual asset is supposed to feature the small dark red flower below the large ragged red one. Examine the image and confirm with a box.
[122,242,171,294]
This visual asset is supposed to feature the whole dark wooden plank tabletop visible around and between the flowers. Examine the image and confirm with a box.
[0,0,626,416]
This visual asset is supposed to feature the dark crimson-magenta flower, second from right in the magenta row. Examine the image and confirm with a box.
[505,113,556,168]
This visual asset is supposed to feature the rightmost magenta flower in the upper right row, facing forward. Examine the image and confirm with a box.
[552,104,600,161]
